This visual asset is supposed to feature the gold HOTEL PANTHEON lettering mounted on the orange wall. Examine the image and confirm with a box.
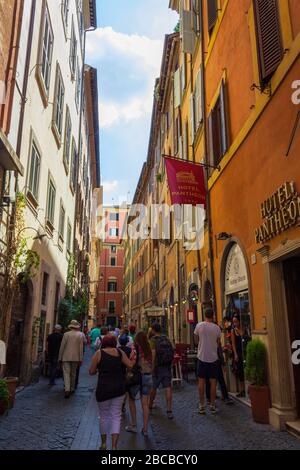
[255,182,300,243]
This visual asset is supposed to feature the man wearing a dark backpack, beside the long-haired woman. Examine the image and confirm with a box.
[149,323,174,419]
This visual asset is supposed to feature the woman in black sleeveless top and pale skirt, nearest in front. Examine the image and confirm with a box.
[89,335,133,450]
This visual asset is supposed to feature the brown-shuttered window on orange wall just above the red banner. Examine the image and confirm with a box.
[208,81,228,165]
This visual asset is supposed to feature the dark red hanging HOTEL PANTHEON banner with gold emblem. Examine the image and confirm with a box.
[165,157,206,206]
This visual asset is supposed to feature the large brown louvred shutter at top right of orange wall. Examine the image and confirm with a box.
[254,0,283,85]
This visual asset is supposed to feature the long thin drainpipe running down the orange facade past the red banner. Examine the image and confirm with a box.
[200,0,217,317]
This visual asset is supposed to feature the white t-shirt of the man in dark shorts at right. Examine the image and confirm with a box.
[194,322,221,363]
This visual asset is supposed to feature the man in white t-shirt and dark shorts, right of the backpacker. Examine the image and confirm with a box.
[194,309,221,414]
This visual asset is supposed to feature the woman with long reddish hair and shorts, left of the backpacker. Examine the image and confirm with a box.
[125,331,153,437]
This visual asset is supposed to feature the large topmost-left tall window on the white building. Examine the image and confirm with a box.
[39,6,54,96]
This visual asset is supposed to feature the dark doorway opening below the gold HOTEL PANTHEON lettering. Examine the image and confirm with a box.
[283,255,300,418]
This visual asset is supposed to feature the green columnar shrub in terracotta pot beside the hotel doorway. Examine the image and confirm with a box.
[245,339,271,424]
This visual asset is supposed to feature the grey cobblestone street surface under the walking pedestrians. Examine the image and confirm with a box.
[0,351,300,450]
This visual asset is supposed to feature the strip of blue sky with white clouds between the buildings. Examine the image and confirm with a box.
[87,0,178,205]
